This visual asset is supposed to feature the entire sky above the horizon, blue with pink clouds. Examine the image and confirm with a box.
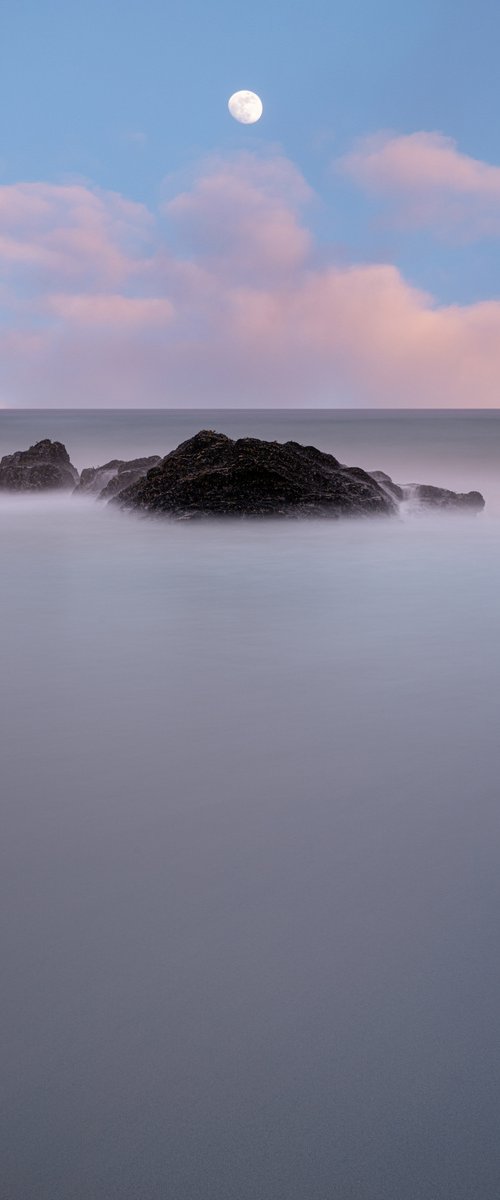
[0,0,500,408]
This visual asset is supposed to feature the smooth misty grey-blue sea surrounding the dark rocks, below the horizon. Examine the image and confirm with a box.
[0,409,500,1200]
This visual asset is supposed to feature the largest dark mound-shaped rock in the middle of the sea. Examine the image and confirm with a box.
[116,430,397,517]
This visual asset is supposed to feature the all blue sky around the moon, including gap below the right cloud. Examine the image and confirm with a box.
[0,0,500,408]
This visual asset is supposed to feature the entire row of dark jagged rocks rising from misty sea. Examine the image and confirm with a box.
[0,430,484,517]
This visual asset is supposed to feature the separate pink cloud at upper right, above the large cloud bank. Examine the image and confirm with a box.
[337,132,500,240]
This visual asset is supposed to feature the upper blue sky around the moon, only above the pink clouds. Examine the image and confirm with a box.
[0,0,500,180]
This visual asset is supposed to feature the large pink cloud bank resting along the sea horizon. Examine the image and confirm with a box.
[0,155,500,407]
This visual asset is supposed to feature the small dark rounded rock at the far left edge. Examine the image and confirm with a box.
[0,438,78,492]
